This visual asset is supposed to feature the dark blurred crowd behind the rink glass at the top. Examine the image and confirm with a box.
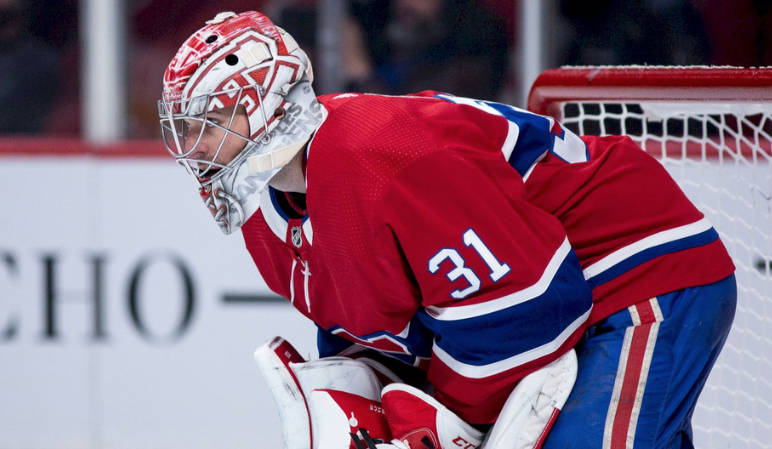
[0,0,772,138]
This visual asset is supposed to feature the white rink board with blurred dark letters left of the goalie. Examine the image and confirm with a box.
[0,156,316,449]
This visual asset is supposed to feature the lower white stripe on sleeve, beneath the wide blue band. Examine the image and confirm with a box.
[432,309,592,379]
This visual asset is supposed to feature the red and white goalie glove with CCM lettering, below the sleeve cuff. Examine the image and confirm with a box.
[379,383,484,449]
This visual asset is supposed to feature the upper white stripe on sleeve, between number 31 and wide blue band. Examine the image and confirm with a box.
[426,238,571,321]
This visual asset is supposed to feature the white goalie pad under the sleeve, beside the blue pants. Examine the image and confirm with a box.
[483,349,578,449]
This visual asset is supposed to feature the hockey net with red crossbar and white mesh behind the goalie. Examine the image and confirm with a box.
[528,67,772,448]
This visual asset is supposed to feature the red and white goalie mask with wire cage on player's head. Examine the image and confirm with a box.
[158,12,326,234]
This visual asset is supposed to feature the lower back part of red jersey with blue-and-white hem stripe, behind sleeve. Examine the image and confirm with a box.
[526,137,734,323]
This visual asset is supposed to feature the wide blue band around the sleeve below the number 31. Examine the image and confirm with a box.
[418,251,592,367]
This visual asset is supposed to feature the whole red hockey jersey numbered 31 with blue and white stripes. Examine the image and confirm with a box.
[242,93,733,424]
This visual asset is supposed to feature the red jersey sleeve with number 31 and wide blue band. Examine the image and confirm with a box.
[379,150,592,424]
